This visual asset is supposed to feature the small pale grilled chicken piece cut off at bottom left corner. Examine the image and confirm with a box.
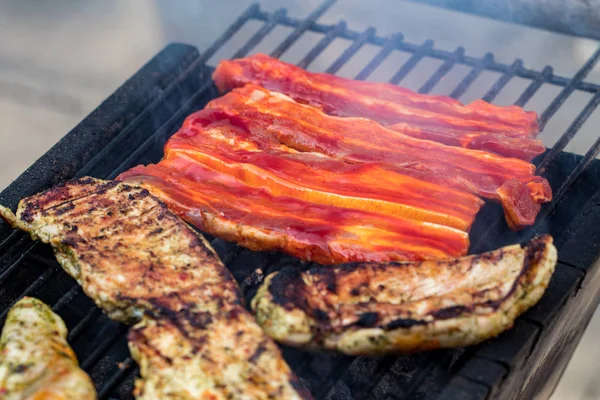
[0,297,96,400]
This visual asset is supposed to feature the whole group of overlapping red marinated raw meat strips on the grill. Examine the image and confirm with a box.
[119,55,552,263]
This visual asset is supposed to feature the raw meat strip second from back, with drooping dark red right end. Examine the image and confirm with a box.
[204,85,552,230]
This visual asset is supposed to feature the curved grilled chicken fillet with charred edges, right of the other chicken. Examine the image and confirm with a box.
[252,236,557,355]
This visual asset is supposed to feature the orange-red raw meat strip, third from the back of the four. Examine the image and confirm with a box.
[165,109,483,230]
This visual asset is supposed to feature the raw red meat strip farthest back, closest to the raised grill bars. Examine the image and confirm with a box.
[213,54,545,160]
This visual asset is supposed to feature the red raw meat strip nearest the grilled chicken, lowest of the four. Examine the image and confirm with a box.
[118,155,469,264]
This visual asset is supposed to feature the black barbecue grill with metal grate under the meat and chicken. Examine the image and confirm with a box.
[0,0,600,399]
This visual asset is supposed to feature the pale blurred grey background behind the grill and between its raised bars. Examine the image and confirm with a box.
[0,0,600,400]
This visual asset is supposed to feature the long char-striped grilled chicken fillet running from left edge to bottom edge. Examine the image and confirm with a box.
[0,178,310,400]
